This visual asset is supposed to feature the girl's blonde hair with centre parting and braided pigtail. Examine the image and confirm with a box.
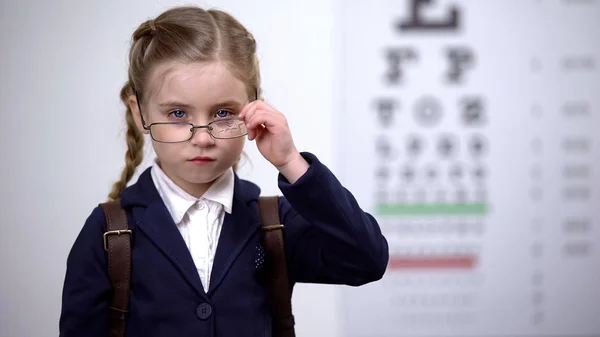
[108,6,261,200]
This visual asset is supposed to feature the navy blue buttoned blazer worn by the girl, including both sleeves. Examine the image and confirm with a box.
[60,153,388,337]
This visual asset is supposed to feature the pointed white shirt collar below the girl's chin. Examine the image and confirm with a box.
[150,159,235,224]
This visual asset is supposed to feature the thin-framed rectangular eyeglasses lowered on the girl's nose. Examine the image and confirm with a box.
[135,90,258,143]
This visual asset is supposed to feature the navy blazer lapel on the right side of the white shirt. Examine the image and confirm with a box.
[208,197,260,296]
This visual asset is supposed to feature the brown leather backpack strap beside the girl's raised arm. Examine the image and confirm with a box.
[258,196,295,337]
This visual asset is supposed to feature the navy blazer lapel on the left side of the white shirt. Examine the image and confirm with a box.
[134,200,206,297]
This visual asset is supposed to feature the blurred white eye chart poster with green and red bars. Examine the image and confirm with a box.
[335,0,600,337]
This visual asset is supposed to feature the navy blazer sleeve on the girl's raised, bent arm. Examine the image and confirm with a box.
[279,152,389,286]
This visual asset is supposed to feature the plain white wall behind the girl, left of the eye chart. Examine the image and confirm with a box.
[0,0,340,337]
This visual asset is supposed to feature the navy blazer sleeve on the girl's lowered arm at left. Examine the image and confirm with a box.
[59,207,112,337]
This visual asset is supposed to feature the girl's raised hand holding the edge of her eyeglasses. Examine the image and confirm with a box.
[240,100,309,184]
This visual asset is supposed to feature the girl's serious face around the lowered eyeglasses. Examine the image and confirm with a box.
[130,62,248,197]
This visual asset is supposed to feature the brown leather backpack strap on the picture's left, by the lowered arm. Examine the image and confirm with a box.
[100,200,132,337]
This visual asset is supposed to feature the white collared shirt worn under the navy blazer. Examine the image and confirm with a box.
[150,160,234,292]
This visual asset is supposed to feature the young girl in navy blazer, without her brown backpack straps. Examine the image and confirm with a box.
[60,7,388,337]
